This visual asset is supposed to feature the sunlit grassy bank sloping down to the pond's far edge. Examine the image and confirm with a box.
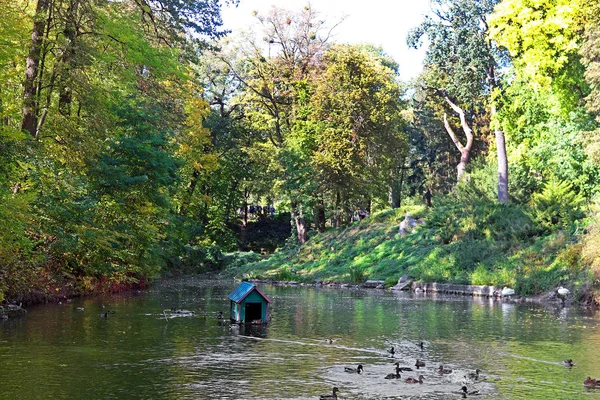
[223,200,596,297]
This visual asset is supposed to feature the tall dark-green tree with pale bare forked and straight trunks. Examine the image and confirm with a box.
[408,0,508,203]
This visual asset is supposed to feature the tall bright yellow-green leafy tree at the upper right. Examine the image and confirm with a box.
[490,0,597,201]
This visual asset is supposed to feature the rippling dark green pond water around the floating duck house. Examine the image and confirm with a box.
[0,279,600,400]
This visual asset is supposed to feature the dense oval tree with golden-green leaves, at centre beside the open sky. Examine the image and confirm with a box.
[308,45,406,221]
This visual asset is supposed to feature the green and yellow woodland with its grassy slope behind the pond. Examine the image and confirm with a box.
[0,0,600,301]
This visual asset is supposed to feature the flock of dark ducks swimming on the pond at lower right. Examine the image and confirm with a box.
[319,342,600,400]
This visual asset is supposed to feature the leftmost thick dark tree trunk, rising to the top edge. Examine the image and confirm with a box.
[21,0,50,138]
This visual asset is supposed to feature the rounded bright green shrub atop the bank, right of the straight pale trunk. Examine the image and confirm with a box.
[532,179,585,229]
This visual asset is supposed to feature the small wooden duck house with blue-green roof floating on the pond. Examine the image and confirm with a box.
[227,282,271,324]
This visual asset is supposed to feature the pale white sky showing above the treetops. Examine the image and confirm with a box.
[222,0,429,81]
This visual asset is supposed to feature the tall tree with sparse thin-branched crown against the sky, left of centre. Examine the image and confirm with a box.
[225,6,335,243]
